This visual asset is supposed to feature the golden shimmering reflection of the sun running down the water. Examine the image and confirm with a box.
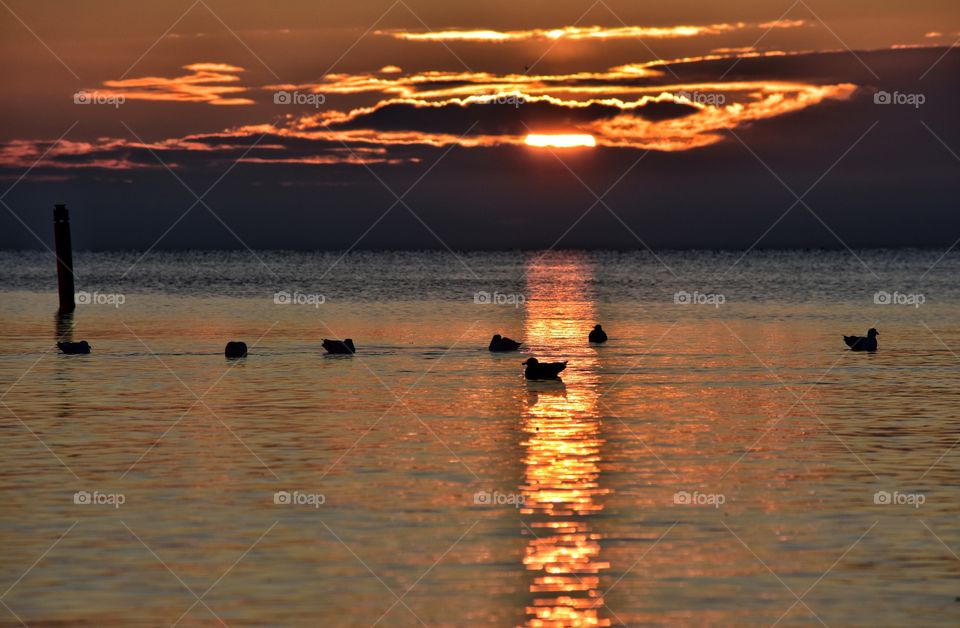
[521,255,610,626]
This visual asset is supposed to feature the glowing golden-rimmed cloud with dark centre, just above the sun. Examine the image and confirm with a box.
[298,81,857,152]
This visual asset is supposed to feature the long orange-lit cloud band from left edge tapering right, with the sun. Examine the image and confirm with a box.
[0,76,857,170]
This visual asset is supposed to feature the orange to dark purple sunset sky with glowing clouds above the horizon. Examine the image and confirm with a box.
[0,0,960,250]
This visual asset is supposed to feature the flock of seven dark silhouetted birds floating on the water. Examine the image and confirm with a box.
[50,325,880,380]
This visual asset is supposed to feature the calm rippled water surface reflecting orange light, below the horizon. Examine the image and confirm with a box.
[0,251,960,626]
